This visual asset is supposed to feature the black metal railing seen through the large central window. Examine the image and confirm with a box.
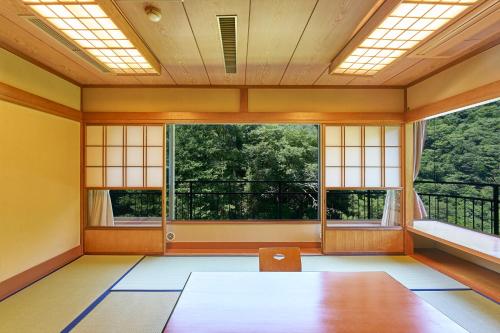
[175,180,318,220]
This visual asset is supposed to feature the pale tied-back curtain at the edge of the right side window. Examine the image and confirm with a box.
[413,120,427,220]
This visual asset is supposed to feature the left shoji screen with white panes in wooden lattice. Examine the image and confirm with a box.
[85,125,165,188]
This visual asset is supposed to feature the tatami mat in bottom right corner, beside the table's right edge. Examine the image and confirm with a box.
[415,290,500,333]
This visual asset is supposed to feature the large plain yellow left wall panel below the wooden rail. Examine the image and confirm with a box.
[0,101,80,281]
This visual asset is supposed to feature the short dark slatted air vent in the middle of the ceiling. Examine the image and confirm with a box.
[217,15,237,74]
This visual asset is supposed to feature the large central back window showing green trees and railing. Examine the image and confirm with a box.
[175,125,319,220]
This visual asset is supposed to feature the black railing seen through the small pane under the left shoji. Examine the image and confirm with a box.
[109,190,162,220]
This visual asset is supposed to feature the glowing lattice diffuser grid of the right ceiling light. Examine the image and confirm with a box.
[333,0,478,76]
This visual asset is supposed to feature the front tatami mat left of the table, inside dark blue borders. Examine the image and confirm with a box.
[71,292,180,333]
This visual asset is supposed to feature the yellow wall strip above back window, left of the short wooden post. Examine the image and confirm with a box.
[82,88,240,112]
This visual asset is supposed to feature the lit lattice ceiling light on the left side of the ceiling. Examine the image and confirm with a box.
[23,0,160,75]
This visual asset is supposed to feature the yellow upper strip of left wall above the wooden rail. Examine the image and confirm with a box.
[0,48,80,110]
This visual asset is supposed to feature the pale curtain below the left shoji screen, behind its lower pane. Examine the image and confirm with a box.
[87,190,114,227]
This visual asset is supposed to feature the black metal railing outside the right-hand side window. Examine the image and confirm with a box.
[415,181,499,235]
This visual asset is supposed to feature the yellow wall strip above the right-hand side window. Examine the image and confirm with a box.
[408,45,500,110]
